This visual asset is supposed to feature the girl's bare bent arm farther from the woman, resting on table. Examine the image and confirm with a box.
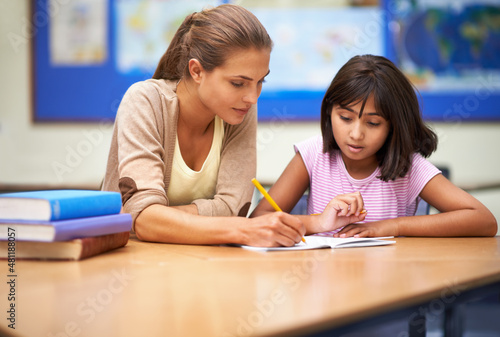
[336,174,497,237]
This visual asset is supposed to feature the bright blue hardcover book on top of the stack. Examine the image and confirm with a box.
[0,190,122,221]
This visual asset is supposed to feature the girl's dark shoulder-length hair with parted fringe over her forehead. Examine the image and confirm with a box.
[321,55,437,181]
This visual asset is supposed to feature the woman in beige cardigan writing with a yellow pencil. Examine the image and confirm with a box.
[103,5,305,246]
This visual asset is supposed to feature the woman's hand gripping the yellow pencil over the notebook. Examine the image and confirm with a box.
[240,212,306,247]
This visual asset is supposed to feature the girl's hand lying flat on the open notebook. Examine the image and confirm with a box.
[333,219,399,238]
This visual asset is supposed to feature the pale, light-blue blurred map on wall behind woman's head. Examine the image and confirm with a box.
[114,0,383,91]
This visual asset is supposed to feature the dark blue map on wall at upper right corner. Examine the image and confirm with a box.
[389,0,500,92]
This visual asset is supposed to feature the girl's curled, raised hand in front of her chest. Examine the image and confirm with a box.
[315,192,366,233]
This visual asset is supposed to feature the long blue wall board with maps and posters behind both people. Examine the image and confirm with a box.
[32,0,500,122]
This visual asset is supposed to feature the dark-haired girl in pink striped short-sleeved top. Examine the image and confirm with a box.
[251,55,497,237]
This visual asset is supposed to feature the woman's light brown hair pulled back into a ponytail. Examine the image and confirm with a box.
[153,4,273,80]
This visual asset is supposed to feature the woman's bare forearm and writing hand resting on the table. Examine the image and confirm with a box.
[135,204,305,247]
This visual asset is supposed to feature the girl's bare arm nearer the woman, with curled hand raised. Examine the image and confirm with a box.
[250,152,365,234]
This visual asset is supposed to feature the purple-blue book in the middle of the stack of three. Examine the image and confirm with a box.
[0,213,132,242]
